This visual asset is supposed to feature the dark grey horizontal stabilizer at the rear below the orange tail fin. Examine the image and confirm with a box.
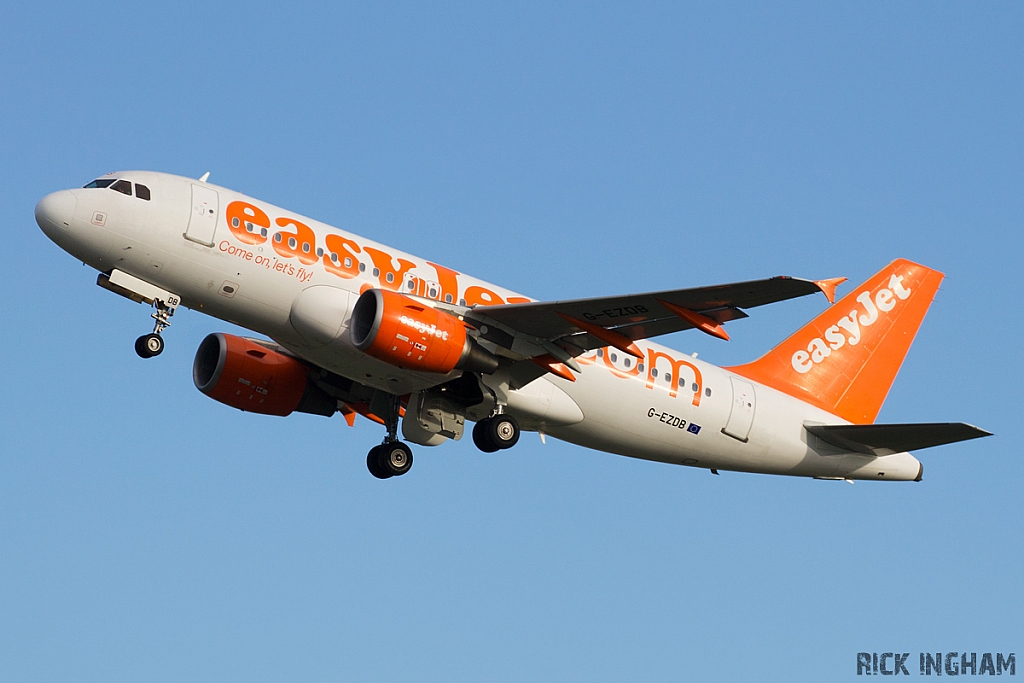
[804,422,992,456]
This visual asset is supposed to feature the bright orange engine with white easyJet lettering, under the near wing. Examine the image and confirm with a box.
[351,289,498,374]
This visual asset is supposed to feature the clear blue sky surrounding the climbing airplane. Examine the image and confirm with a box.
[0,2,1024,681]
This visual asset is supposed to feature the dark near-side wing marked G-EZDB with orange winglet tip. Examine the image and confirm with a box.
[465,276,844,362]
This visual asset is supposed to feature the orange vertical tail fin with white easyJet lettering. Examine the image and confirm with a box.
[727,259,943,424]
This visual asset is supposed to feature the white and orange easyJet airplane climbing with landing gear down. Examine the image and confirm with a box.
[35,171,990,482]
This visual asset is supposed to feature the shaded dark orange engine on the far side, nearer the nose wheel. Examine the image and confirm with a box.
[193,333,338,417]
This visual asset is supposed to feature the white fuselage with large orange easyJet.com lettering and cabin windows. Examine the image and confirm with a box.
[37,171,921,480]
